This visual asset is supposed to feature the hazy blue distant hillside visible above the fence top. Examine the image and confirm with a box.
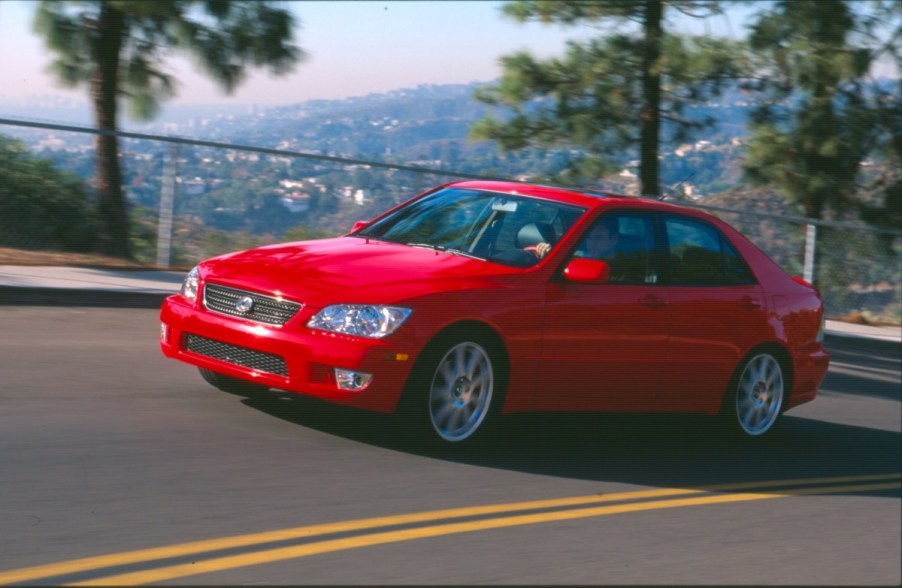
[0,83,888,197]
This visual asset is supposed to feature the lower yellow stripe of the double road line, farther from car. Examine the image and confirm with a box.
[69,483,899,586]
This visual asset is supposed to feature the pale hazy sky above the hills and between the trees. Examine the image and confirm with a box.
[0,0,896,110]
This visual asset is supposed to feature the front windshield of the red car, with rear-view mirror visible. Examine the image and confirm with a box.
[354,187,585,267]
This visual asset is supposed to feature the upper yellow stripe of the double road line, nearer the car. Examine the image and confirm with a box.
[0,473,902,584]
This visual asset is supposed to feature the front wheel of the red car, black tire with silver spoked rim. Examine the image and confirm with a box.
[401,337,506,448]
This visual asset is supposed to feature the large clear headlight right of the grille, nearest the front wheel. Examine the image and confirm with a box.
[307,304,412,339]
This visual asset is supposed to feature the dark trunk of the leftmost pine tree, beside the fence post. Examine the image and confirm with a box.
[91,2,131,259]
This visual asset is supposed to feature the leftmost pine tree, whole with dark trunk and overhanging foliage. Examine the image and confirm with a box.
[34,0,301,258]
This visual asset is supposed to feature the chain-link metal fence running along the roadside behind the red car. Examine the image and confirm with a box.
[0,119,902,325]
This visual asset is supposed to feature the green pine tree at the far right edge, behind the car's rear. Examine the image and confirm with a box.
[745,0,902,218]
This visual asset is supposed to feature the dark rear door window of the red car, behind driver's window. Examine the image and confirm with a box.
[664,217,755,286]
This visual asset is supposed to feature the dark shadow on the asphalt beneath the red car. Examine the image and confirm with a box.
[242,391,902,496]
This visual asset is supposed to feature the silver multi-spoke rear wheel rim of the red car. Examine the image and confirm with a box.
[732,353,785,437]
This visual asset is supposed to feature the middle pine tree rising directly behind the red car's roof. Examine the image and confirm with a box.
[472,0,742,194]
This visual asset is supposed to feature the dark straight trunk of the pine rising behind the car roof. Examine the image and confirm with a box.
[639,0,664,196]
